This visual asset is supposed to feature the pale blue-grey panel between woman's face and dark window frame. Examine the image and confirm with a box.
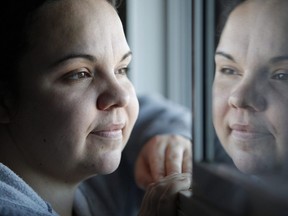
[126,0,192,108]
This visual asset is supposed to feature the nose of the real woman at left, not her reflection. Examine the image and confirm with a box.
[97,78,130,110]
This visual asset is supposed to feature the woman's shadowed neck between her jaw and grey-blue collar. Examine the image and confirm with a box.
[0,126,79,216]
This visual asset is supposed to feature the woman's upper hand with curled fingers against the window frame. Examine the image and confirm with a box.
[135,135,192,189]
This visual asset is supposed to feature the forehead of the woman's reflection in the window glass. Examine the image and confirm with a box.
[217,0,288,61]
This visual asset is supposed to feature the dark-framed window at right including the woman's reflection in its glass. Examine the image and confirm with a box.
[183,0,288,215]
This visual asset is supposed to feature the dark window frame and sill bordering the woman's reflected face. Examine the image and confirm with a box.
[179,0,288,216]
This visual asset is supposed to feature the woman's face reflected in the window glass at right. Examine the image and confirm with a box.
[213,1,288,175]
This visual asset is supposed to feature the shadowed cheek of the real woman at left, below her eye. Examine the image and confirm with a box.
[14,87,96,173]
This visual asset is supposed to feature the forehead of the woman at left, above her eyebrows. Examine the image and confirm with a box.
[25,0,128,63]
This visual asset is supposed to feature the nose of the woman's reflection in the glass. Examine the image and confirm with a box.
[228,80,267,112]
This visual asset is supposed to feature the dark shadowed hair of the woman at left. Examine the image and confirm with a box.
[0,0,119,96]
